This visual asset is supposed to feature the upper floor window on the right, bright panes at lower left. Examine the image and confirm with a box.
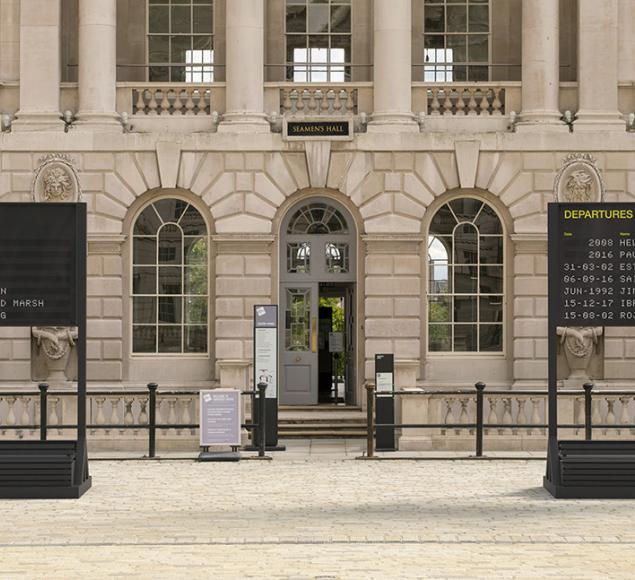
[423,0,490,83]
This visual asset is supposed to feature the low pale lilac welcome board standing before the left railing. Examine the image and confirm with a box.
[200,389,241,447]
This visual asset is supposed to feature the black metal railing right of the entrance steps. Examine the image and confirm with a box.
[366,382,635,458]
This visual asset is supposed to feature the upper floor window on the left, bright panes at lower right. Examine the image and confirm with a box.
[148,0,214,83]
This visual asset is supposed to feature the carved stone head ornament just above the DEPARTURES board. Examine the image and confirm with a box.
[554,153,604,203]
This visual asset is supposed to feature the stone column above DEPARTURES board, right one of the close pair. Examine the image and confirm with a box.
[574,0,625,131]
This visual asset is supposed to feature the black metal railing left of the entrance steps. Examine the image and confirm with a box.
[0,383,267,458]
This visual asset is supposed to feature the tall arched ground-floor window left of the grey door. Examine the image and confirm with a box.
[132,199,209,354]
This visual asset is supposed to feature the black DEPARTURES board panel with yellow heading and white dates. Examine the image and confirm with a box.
[549,203,635,326]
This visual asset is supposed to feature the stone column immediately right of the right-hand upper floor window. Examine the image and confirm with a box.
[517,0,569,131]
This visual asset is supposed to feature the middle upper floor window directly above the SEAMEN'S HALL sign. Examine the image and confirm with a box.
[286,0,351,83]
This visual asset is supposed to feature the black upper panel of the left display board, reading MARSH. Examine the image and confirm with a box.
[0,203,86,326]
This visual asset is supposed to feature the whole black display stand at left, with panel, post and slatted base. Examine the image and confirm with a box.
[0,203,91,499]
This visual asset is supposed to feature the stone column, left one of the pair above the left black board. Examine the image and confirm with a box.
[12,0,64,131]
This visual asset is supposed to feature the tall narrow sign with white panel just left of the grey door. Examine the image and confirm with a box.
[252,304,285,451]
